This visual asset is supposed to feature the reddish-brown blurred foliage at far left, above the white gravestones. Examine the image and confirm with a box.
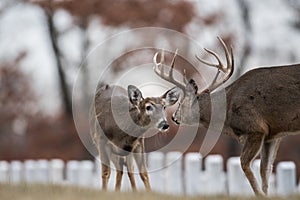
[0,53,91,160]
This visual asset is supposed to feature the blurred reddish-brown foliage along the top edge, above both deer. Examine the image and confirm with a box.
[30,0,194,32]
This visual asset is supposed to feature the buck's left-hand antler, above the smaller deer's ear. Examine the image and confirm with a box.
[153,49,187,91]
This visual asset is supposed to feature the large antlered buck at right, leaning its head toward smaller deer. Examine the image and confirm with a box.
[153,37,300,195]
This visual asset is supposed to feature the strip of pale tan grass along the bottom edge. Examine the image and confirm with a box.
[0,184,300,200]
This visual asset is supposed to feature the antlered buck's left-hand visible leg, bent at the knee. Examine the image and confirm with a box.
[241,133,264,196]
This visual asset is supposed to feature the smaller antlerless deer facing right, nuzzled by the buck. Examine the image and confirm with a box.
[90,85,179,191]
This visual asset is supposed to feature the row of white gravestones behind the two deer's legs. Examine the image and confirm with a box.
[0,152,300,196]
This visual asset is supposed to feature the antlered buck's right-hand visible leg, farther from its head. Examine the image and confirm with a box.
[260,139,280,195]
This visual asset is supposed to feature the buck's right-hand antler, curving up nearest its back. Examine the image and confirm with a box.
[196,37,234,92]
